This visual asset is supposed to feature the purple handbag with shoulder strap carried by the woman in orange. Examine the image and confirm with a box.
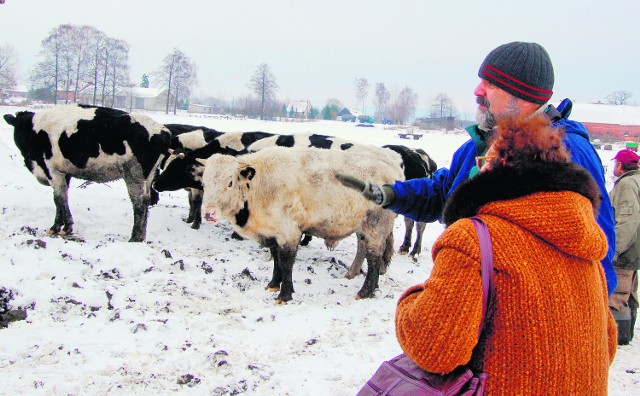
[357,217,493,396]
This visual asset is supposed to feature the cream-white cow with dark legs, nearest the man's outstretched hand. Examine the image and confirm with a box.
[202,146,404,303]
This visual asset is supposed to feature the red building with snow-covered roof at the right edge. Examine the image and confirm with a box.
[569,103,640,143]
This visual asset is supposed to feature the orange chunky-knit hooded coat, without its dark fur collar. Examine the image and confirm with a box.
[396,191,617,395]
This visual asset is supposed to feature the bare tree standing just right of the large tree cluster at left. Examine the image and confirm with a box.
[155,48,197,114]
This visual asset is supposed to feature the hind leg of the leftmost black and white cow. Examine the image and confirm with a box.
[123,166,150,242]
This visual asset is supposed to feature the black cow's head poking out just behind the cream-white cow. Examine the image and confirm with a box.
[153,152,204,192]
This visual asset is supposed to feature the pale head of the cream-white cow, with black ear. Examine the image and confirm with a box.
[202,154,256,227]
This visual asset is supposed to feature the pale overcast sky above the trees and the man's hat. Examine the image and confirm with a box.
[0,0,640,114]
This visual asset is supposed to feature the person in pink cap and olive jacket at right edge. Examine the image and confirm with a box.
[609,150,640,345]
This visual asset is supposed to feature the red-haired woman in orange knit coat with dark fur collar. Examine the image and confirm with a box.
[396,116,617,395]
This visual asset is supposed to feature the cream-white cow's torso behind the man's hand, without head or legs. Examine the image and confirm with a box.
[228,147,404,239]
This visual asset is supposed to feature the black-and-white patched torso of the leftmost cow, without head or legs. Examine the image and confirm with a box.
[33,105,170,182]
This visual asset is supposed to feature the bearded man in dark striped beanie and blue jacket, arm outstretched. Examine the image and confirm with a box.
[340,42,617,293]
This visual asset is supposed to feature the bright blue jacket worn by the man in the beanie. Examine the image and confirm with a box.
[387,99,618,295]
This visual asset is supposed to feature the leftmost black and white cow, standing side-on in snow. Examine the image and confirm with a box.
[4,104,171,242]
